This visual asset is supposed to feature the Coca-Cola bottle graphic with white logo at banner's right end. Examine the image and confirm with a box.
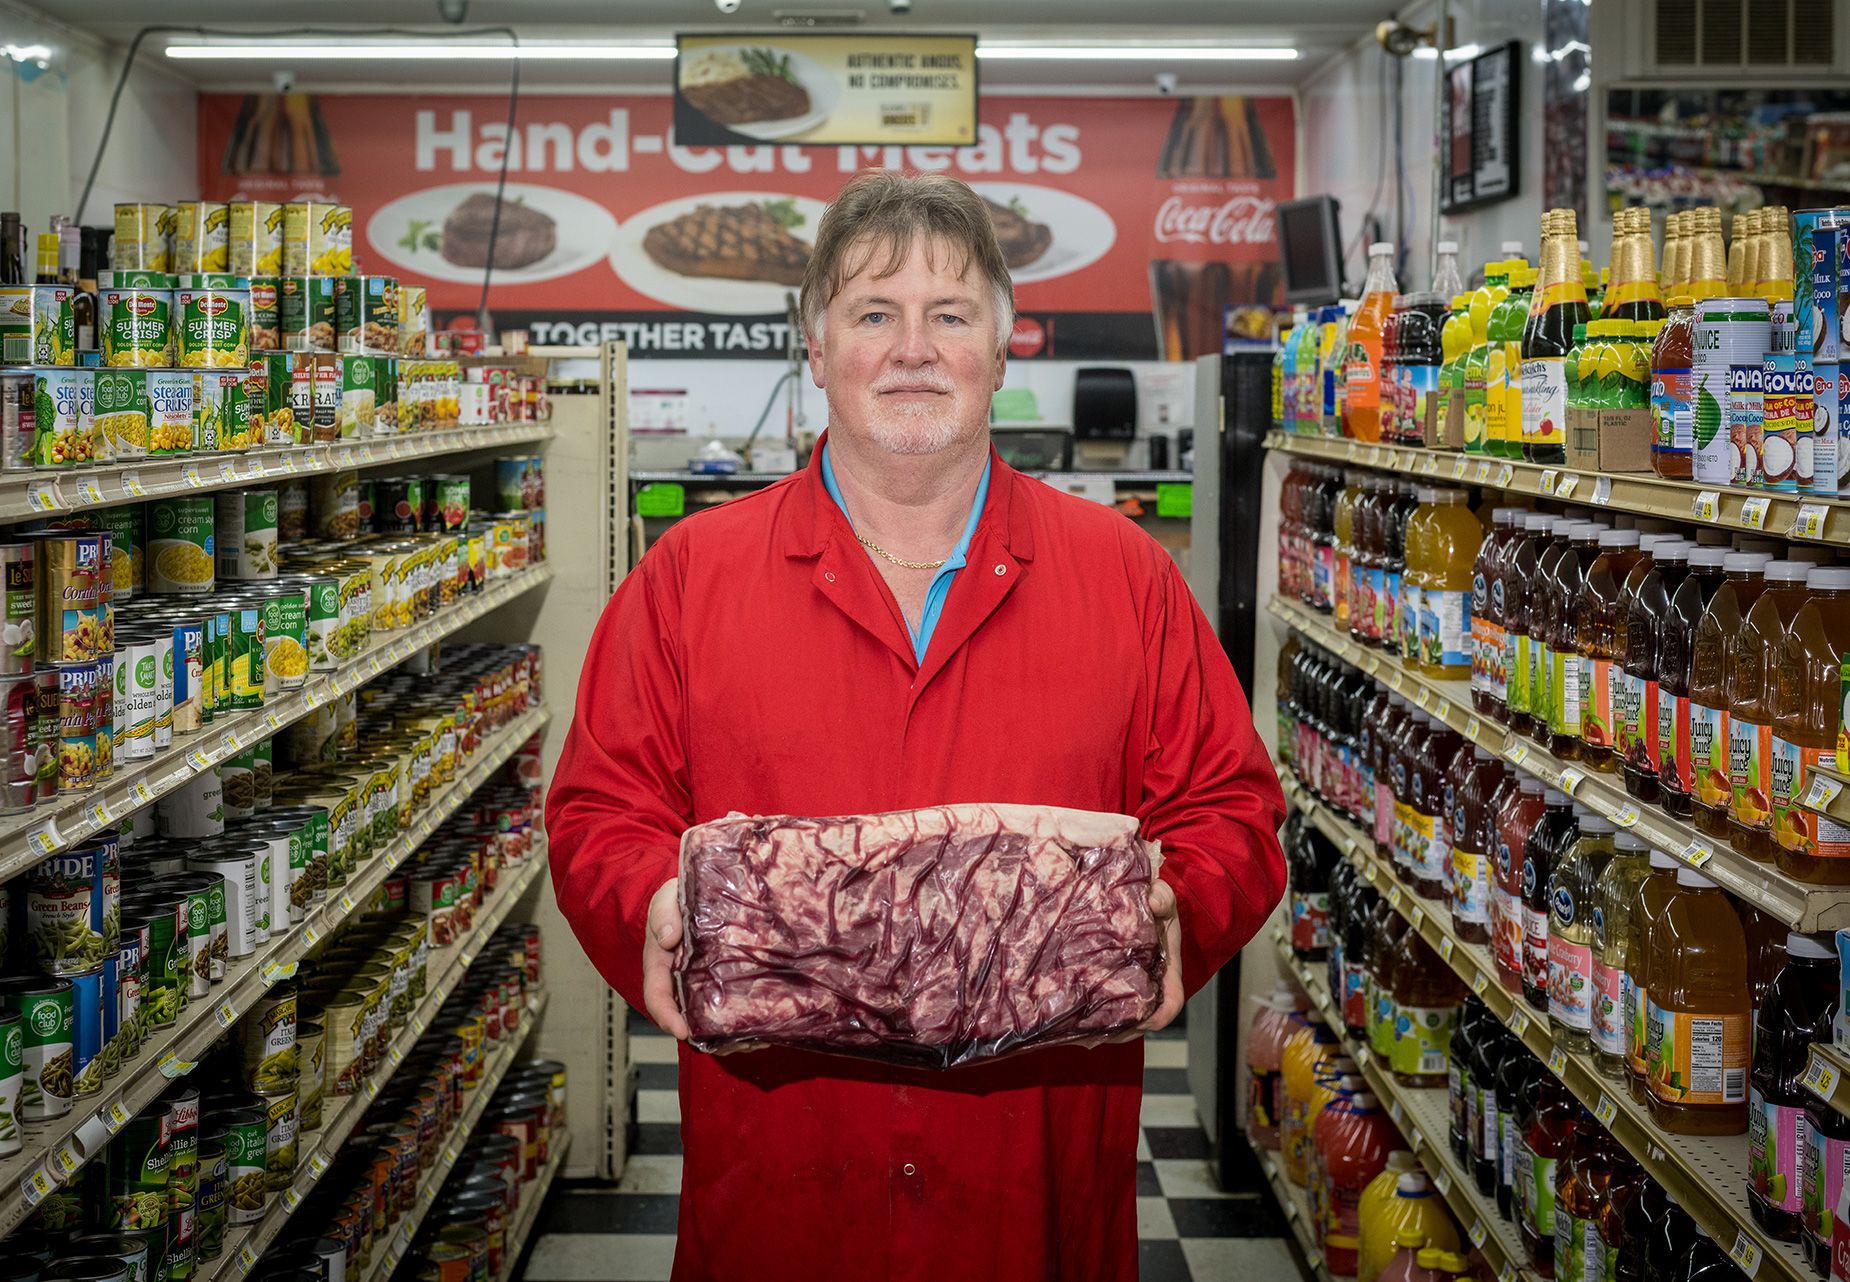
[1149,98,1289,361]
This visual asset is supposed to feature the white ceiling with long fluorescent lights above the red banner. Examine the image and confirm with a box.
[41,0,1388,92]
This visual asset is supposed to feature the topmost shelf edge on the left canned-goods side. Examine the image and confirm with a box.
[0,422,553,522]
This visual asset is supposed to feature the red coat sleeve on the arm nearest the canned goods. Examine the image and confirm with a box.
[546,540,694,1010]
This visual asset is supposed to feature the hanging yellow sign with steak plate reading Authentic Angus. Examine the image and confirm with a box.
[675,35,977,146]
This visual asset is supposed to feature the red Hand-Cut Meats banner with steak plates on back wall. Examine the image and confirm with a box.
[200,94,1295,359]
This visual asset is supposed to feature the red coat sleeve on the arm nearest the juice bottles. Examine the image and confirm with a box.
[1138,553,1284,995]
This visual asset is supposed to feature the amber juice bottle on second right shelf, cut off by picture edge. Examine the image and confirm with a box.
[1772,566,1850,880]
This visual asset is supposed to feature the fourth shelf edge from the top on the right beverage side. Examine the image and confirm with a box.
[1267,927,1537,1282]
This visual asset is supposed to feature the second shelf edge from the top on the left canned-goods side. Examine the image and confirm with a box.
[0,564,553,881]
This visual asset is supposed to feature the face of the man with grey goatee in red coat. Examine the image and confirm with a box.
[810,239,1005,455]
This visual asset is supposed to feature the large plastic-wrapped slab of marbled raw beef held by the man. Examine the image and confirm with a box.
[675,805,1164,1067]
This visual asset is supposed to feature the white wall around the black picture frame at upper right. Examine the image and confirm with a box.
[1299,0,1554,289]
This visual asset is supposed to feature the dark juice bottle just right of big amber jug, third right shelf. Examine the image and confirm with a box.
[1746,934,1837,1241]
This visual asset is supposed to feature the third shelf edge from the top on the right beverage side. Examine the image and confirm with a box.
[1286,771,1813,1282]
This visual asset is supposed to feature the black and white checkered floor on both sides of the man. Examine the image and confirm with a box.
[524,1014,1299,1282]
